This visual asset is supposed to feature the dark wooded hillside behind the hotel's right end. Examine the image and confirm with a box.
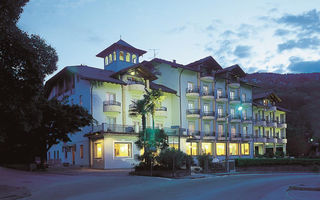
[246,73,320,155]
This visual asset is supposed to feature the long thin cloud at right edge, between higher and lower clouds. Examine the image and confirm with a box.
[278,37,320,52]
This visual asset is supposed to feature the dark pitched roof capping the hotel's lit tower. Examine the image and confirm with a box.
[96,39,146,58]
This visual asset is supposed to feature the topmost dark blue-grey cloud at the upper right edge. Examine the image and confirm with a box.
[276,9,320,34]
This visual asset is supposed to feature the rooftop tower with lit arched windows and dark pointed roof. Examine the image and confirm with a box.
[97,39,146,72]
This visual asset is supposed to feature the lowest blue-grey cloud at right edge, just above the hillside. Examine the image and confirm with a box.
[288,59,320,73]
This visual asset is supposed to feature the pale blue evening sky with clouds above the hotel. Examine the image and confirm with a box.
[18,0,320,77]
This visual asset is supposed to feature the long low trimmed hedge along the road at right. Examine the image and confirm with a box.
[235,158,320,167]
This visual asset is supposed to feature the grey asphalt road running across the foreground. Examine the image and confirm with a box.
[0,169,320,200]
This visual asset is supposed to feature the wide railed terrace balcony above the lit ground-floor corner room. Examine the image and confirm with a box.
[93,123,138,134]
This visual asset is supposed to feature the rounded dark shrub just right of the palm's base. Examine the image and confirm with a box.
[156,148,189,170]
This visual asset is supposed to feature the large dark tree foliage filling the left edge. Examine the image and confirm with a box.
[0,0,91,163]
